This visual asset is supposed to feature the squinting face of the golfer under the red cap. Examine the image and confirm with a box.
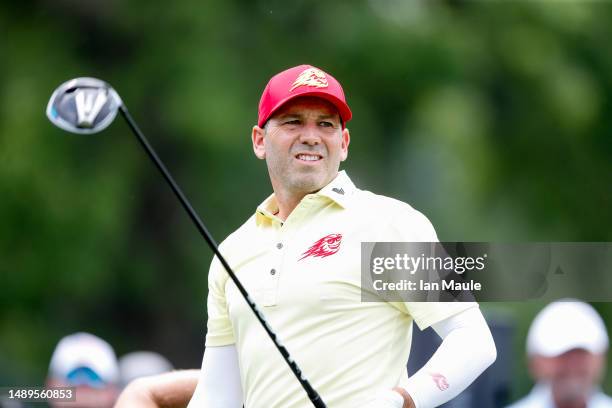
[263,97,349,194]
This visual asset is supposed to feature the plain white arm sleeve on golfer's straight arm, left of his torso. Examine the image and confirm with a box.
[187,345,243,408]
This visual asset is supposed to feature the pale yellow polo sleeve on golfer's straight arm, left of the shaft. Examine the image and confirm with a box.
[206,256,235,347]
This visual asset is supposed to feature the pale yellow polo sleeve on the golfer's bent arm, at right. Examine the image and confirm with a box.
[390,205,478,330]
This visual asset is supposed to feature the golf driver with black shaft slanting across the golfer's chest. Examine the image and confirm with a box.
[47,77,326,408]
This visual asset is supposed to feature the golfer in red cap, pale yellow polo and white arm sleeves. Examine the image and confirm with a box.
[116,65,496,408]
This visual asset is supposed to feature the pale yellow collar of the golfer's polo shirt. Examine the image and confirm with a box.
[255,170,356,225]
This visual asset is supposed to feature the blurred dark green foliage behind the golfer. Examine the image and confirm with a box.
[0,0,612,404]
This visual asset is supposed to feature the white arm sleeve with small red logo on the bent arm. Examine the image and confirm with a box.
[406,307,497,408]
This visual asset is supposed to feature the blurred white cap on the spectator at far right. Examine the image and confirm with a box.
[527,299,608,357]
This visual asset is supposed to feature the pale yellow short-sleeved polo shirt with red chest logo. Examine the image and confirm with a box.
[206,171,477,408]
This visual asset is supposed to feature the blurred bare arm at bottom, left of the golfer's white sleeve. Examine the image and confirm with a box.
[115,370,200,408]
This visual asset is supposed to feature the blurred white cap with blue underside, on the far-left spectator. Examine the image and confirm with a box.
[49,333,119,386]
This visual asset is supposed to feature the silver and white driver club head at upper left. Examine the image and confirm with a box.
[47,77,123,134]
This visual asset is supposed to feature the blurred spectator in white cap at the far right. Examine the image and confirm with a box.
[511,299,612,408]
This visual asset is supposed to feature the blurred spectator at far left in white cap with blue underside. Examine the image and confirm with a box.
[46,333,119,408]
